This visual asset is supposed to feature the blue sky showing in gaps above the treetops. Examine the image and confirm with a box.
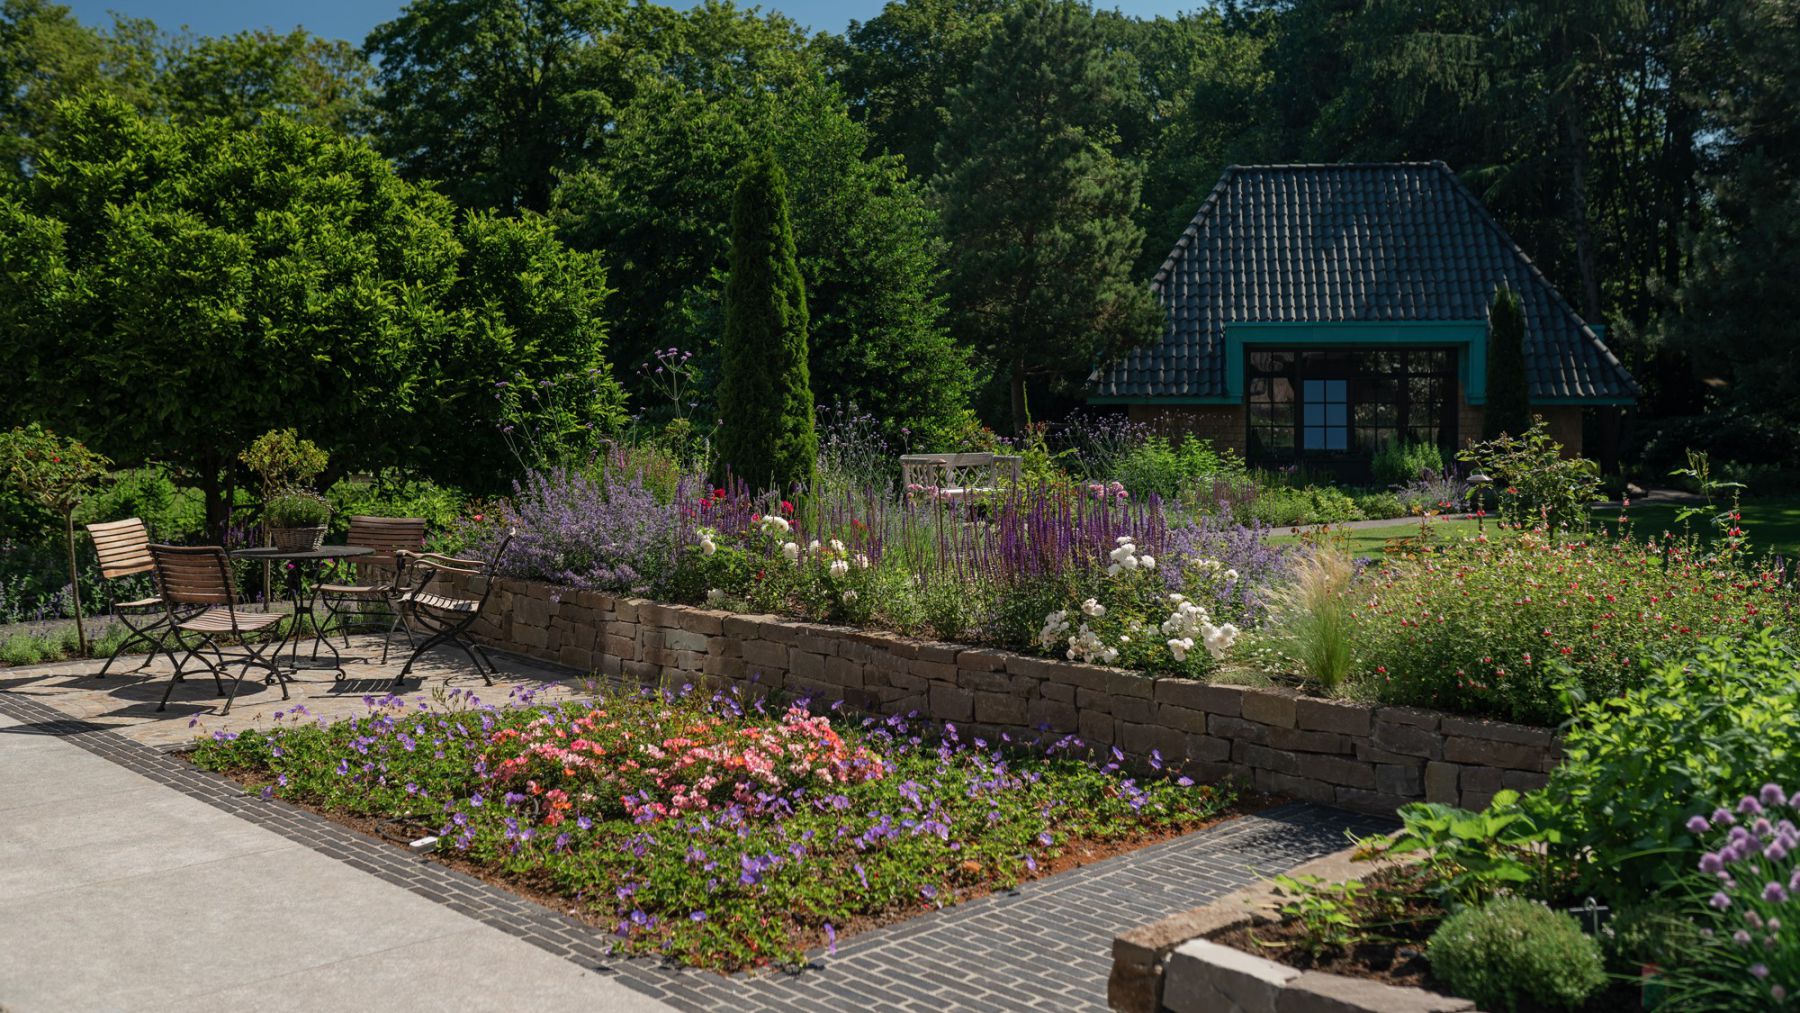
[63,0,1204,43]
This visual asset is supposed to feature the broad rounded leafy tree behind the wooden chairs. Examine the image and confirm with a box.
[0,97,616,534]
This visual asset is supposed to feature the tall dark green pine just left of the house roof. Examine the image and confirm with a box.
[936,0,1161,432]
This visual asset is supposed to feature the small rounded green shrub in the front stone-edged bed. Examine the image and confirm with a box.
[1426,898,1606,1009]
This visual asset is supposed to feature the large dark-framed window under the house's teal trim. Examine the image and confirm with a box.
[1244,349,1456,462]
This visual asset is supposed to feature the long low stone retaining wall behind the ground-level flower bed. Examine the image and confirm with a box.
[477,579,1561,813]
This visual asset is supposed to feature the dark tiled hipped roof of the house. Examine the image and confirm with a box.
[1089,162,1638,399]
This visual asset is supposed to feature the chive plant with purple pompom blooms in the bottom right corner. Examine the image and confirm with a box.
[1669,783,1800,1011]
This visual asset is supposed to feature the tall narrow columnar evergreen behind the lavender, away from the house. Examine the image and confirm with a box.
[716,155,819,493]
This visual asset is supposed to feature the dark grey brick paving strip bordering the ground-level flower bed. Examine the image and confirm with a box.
[0,693,1390,1013]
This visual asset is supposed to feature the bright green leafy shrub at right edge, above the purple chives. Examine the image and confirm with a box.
[1532,630,1800,900]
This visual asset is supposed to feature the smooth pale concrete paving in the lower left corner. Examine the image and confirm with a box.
[0,716,668,1013]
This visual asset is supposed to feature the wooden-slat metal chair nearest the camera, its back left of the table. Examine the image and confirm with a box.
[149,545,288,714]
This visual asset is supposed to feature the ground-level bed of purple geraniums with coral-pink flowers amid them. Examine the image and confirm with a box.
[193,691,1231,970]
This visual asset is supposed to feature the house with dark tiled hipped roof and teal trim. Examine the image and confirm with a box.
[1089,162,1638,479]
